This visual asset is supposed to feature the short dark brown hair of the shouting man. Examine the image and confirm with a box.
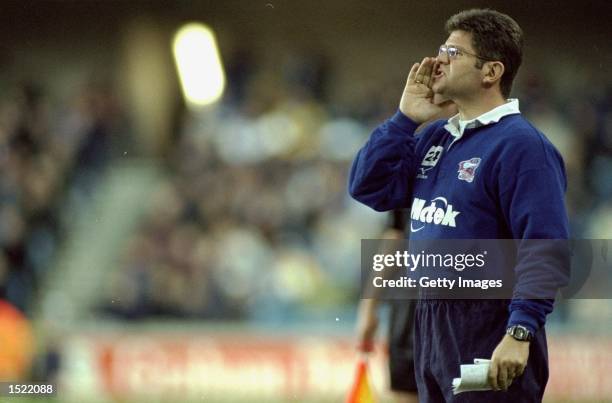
[445,9,523,98]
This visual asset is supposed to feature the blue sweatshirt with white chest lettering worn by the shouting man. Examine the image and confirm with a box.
[349,107,569,333]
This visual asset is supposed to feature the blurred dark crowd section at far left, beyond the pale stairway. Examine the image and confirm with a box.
[0,82,126,312]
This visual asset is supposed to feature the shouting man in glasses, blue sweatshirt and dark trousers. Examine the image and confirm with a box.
[349,10,569,403]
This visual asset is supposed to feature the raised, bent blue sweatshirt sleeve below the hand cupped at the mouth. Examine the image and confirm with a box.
[349,110,419,211]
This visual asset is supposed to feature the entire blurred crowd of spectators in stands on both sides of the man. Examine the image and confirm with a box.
[0,51,612,321]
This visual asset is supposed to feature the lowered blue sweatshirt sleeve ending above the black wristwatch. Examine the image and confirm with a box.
[500,132,570,333]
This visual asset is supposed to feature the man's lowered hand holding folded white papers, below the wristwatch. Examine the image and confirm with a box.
[489,335,529,390]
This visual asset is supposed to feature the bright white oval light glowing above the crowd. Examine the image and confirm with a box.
[172,23,225,107]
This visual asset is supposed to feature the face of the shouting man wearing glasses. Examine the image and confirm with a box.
[432,31,482,99]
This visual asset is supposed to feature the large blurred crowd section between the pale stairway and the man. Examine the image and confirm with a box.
[107,52,384,321]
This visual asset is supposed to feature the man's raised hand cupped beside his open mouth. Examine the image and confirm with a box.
[400,57,452,123]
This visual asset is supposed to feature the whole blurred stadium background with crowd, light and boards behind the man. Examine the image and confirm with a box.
[0,0,612,402]
